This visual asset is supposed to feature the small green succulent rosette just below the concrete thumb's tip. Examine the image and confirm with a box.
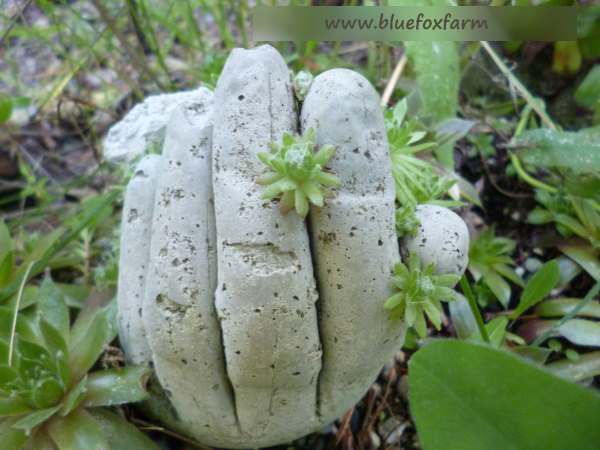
[384,253,460,337]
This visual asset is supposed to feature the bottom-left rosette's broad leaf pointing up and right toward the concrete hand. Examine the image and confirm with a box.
[69,300,117,380]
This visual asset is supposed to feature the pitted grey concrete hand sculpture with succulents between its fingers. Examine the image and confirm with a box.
[112,46,468,448]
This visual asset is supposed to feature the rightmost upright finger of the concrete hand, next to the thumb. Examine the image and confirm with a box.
[301,69,405,419]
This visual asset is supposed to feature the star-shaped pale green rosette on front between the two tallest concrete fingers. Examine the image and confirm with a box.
[258,129,340,218]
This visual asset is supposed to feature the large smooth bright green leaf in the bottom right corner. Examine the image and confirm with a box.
[408,340,600,450]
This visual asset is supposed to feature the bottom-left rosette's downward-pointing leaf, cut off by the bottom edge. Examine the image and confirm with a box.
[48,408,109,450]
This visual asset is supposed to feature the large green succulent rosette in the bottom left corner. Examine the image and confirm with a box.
[0,280,157,450]
